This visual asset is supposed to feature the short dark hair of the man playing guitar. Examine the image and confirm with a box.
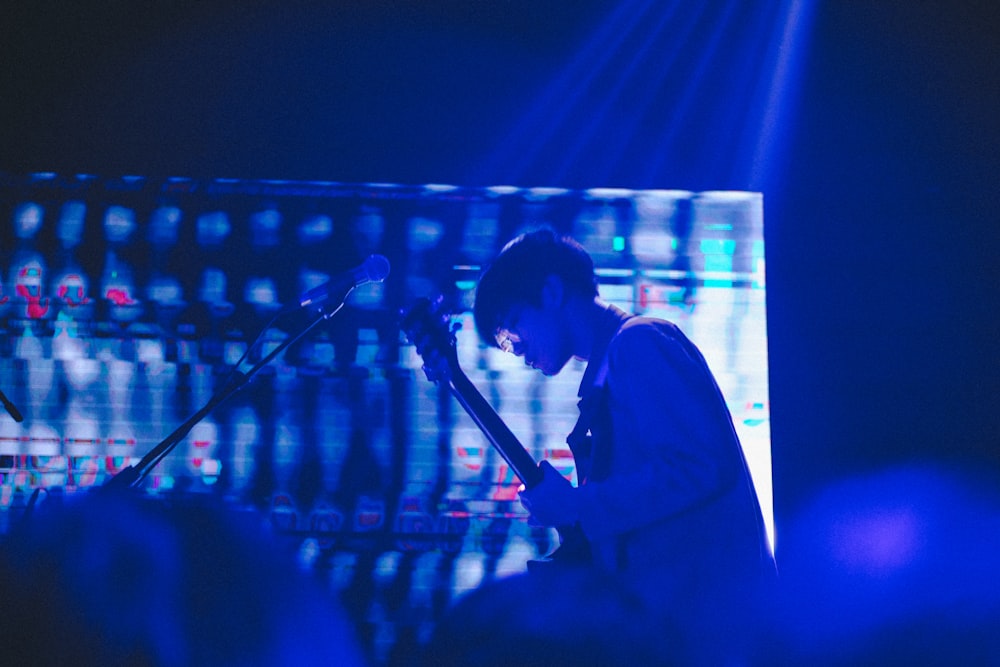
[473,228,597,346]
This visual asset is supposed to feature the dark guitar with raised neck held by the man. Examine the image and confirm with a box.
[400,298,590,571]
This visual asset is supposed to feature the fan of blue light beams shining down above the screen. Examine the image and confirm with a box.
[472,0,816,196]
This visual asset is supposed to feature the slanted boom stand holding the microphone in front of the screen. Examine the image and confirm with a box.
[99,294,353,493]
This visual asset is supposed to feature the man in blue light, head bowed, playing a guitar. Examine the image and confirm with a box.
[474,229,774,606]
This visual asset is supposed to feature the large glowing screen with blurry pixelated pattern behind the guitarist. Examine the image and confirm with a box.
[0,174,771,664]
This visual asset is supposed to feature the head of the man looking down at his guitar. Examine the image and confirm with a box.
[473,229,597,375]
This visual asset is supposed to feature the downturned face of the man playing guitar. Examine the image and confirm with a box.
[497,304,572,375]
